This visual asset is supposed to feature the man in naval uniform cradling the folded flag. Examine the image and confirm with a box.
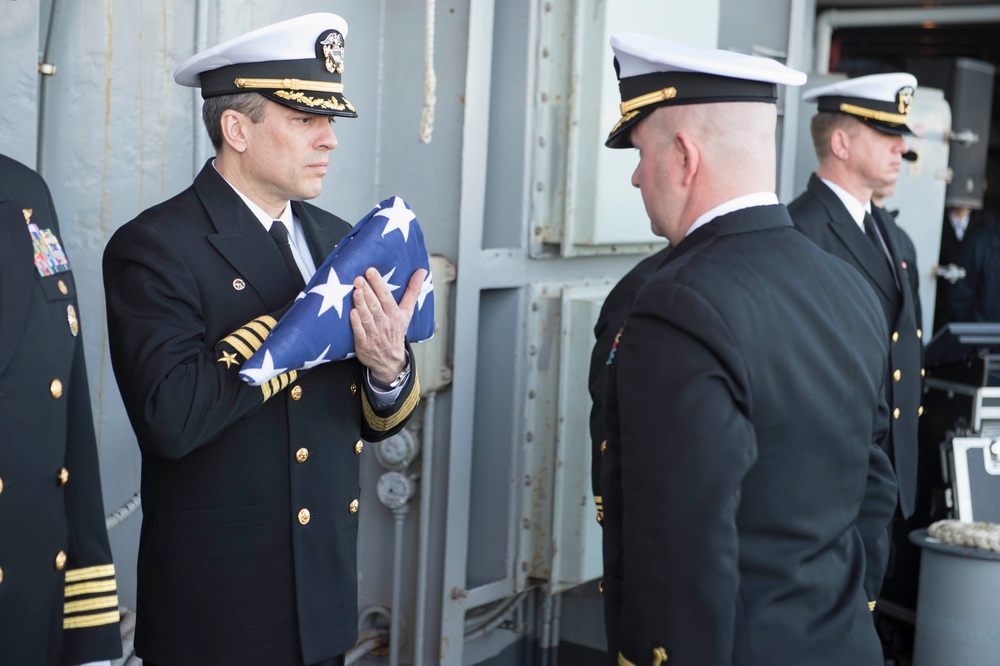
[104,14,425,666]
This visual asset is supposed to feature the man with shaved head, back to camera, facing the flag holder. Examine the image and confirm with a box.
[601,34,896,666]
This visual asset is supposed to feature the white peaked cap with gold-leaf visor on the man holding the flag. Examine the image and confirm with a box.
[174,13,358,118]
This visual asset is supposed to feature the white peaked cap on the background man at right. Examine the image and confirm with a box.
[802,72,917,134]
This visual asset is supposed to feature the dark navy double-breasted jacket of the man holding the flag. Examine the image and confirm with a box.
[104,162,419,666]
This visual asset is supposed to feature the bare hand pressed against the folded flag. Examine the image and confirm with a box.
[351,268,427,384]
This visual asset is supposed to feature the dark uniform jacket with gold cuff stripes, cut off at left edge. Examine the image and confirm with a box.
[0,155,121,666]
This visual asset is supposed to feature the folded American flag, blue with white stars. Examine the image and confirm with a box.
[240,197,434,386]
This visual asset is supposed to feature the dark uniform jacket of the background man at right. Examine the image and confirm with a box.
[788,174,923,518]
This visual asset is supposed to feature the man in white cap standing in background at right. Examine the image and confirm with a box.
[788,73,923,520]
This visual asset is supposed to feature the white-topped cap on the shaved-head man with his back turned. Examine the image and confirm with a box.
[604,32,806,148]
